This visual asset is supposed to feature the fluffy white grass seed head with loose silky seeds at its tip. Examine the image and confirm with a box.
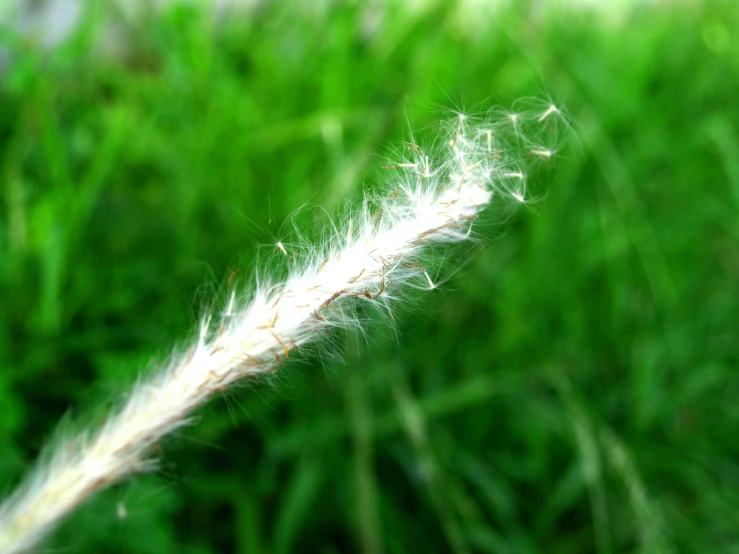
[0,102,560,554]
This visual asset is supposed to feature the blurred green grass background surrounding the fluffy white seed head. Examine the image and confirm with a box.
[0,0,739,554]
